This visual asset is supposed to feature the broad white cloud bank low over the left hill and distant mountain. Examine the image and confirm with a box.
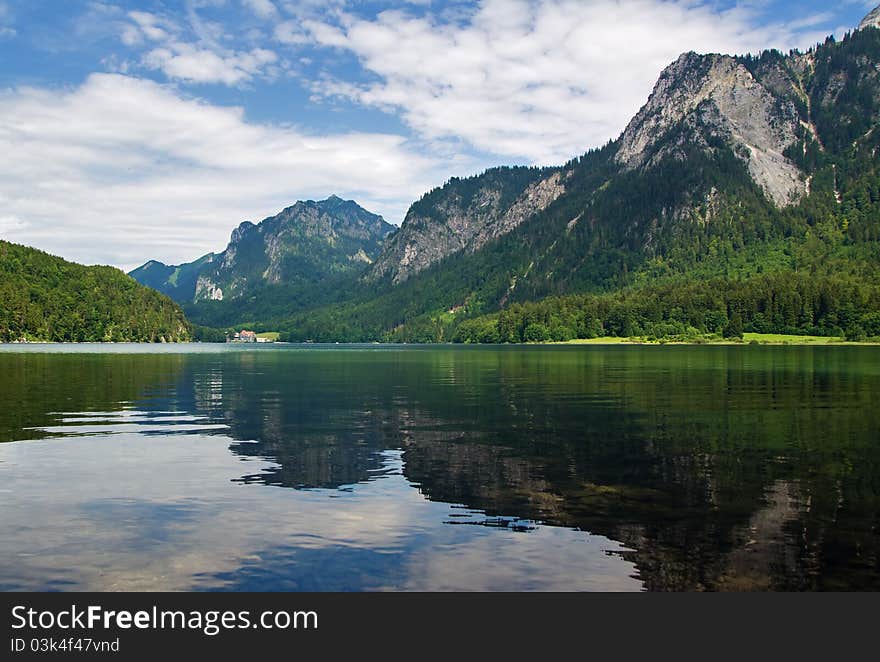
[0,74,439,268]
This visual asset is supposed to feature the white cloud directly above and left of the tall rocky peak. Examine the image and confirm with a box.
[303,0,844,163]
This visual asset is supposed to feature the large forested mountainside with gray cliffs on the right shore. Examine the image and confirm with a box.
[272,28,880,341]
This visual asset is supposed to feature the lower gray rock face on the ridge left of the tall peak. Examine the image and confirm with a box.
[368,170,565,283]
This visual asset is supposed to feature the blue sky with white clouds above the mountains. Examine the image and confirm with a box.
[0,0,874,269]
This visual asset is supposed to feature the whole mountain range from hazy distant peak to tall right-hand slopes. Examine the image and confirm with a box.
[122,7,880,341]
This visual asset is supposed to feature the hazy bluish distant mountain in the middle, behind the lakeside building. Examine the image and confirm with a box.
[130,196,395,303]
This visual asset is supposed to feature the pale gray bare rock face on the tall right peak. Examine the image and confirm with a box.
[616,53,804,207]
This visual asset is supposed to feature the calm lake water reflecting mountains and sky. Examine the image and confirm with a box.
[0,345,880,591]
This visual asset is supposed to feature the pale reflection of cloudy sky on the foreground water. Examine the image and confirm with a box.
[0,435,639,590]
